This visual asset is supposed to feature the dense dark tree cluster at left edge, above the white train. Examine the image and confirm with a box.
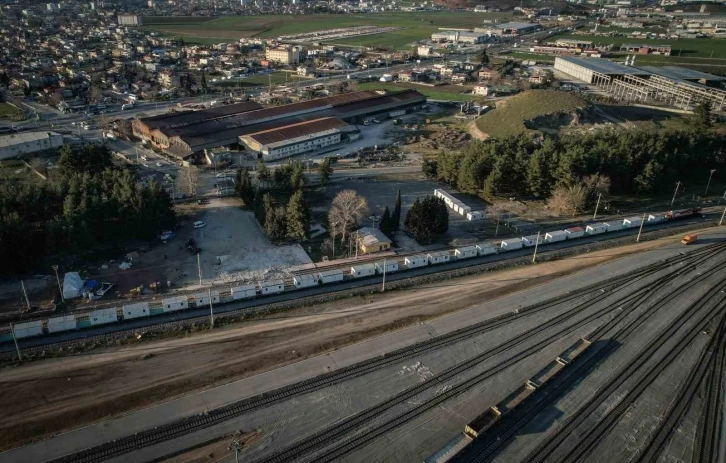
[0,145,176,275]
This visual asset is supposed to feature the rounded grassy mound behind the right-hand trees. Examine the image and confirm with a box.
[476,90,587,138]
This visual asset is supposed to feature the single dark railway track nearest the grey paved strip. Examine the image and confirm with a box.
[47,243,726,462]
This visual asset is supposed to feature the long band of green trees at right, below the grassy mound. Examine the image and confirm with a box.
[422,125,726,203]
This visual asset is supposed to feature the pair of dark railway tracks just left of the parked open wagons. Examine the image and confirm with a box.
[253,243,724,463]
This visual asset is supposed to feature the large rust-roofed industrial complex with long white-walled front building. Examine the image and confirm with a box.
[132,90,426,160]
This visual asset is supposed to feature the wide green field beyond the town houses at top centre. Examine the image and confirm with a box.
[141,12,505,49]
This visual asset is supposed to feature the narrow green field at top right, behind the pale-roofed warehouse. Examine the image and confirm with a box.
[548,34,726,59]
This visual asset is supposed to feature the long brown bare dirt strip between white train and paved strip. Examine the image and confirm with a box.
[0,232,704,449]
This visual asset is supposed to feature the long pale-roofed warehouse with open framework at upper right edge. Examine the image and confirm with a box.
[555,56,726,111]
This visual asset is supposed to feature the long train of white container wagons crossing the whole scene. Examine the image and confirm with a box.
[0,208,701,343]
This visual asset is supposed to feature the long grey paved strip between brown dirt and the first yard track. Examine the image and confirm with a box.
[0,226,726,462]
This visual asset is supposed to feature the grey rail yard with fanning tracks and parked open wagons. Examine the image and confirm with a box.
[3,227,726,462]
